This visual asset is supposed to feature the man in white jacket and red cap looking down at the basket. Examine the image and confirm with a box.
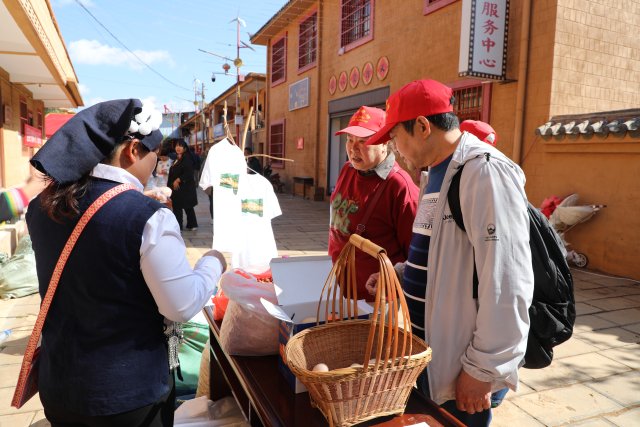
[367,80,533,425]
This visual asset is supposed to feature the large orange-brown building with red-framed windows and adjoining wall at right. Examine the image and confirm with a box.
[251,0,640,279]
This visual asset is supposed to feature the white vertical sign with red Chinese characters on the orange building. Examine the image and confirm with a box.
[458,0,509,80]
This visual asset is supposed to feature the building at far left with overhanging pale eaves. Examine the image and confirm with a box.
[0,0,83,187]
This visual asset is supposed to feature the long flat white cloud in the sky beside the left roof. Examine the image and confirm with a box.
[69,39,173,70]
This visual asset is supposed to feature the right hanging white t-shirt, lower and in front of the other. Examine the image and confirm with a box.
[230,174,282,273]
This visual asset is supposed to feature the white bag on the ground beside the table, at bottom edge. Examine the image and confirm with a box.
[173,396,250,427]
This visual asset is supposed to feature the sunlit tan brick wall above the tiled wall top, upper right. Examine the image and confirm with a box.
[551,0,640,116]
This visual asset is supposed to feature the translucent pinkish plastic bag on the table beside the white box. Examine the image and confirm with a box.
[220,270,279,356]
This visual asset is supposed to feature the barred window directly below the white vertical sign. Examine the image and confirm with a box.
[450,80,491,122]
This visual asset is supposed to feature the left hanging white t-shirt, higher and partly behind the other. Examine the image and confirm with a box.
[200,138,247,252]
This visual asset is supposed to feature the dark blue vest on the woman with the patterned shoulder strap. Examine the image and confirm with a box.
[27,179,169,416]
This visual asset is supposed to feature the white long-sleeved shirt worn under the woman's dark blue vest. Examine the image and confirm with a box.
[91,164,222,322]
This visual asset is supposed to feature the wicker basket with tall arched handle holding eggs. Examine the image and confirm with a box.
[285,235,431,427]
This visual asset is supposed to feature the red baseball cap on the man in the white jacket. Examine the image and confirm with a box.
[367,80,453,145]
